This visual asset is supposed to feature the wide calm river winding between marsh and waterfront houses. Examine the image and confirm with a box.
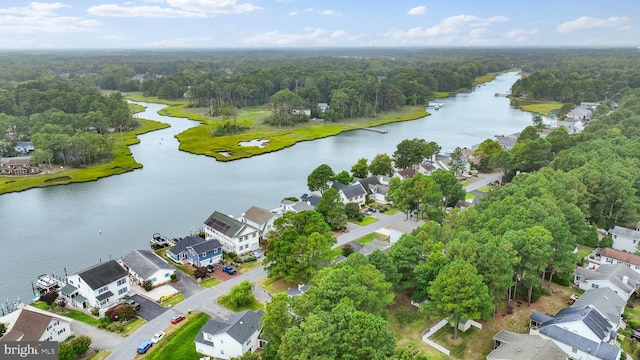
[0,73,532,302]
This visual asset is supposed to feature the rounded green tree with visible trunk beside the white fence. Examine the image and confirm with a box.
[426,260,493,339]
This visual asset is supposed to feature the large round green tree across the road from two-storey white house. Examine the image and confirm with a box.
[265,210,337,283]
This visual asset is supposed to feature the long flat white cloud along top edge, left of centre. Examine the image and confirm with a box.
[87,0,262,18]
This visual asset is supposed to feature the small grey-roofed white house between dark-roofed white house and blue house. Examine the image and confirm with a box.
[122,250,176,287]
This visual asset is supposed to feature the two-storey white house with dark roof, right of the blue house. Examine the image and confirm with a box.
[204,211,260,255]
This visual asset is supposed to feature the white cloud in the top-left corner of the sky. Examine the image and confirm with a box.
[0,2,99,34]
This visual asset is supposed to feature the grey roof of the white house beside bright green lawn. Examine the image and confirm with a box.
[196,310,264,344]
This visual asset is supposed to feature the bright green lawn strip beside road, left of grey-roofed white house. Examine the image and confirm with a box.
[144,313,210,360]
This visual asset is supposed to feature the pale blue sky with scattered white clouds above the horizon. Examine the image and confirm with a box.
[0,0,640,50]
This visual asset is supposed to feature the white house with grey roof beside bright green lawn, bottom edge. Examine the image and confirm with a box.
[195,310,264,359]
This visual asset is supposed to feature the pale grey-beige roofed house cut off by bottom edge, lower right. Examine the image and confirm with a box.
[487,330,569,360]
